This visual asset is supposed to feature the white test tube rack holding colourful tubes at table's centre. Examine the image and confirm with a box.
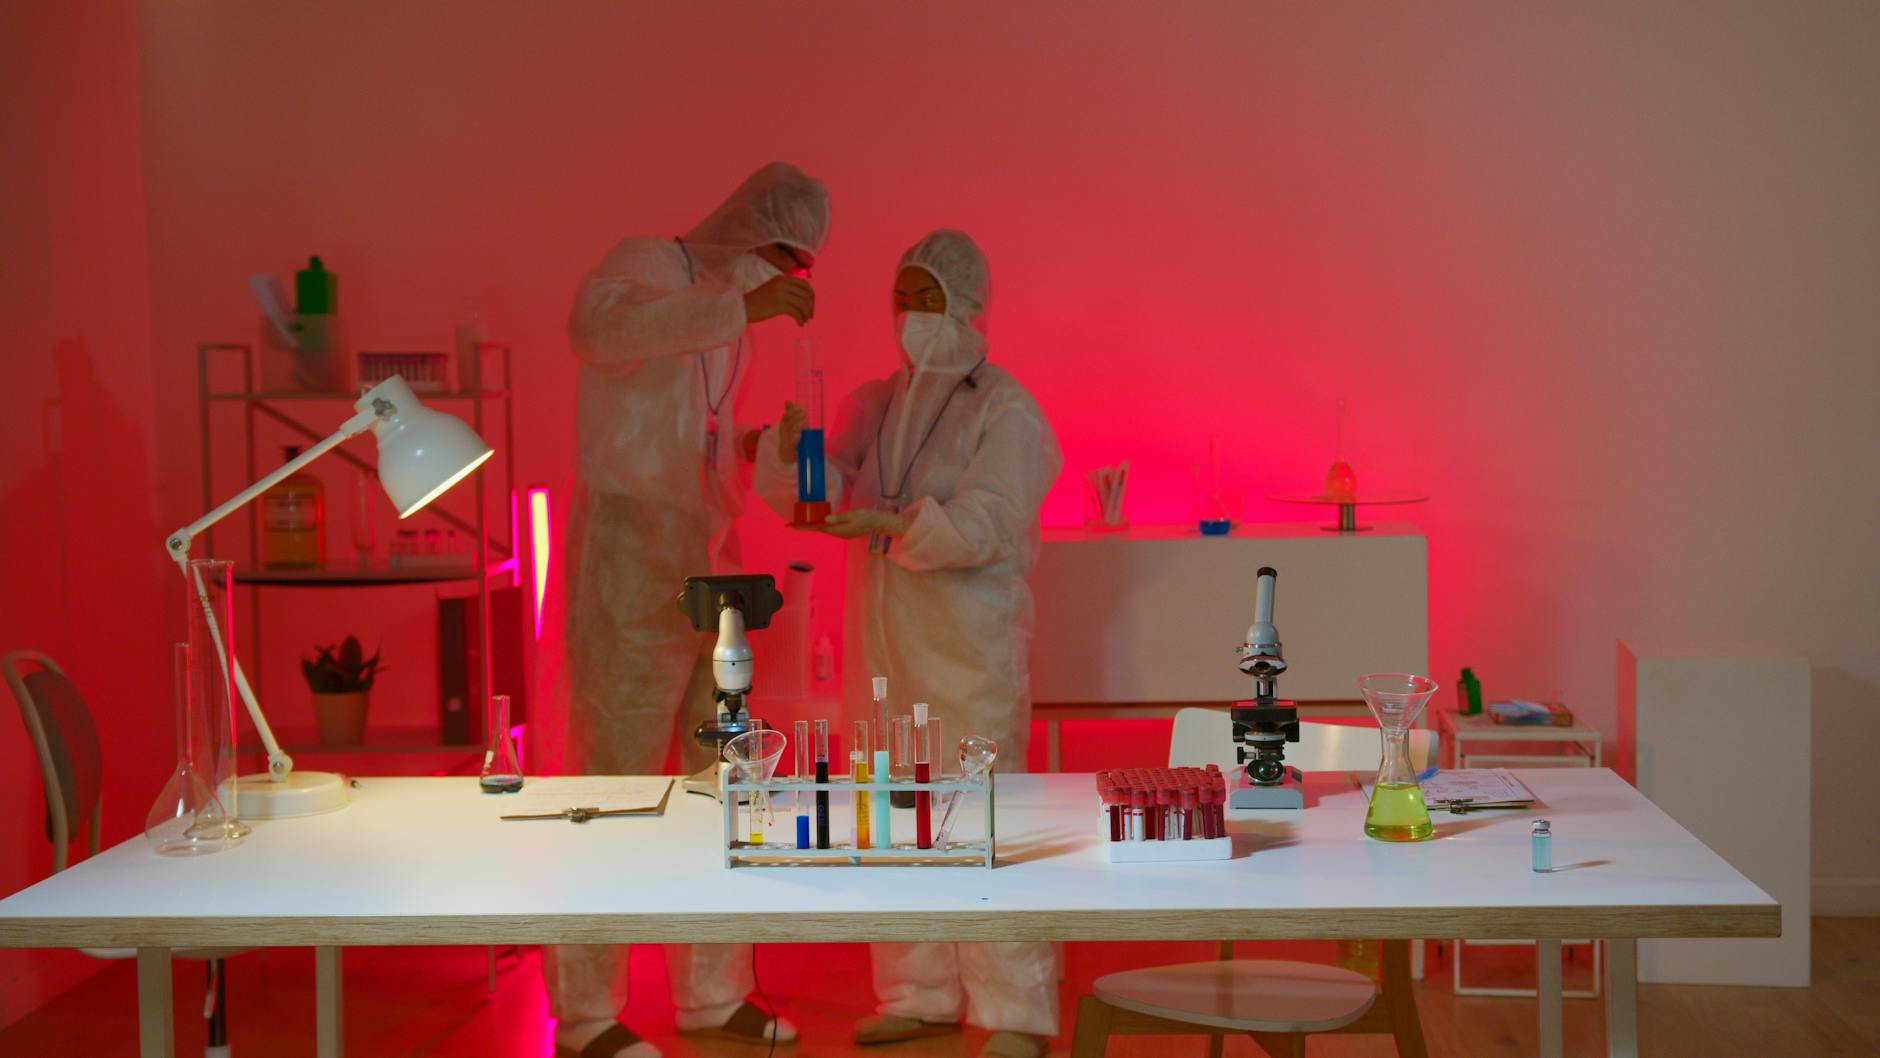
[718,769,996,868]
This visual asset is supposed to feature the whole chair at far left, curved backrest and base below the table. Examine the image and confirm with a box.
[0,650,254,1058]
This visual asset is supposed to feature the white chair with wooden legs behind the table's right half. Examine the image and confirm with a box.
[1072,708,1436,1058]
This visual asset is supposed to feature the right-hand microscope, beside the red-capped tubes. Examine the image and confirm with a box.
[1228,566,1305,808]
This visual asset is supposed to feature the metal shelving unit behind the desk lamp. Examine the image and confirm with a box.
[196,342,521,754]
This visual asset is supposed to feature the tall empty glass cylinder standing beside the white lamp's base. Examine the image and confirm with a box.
[186,558,248,842]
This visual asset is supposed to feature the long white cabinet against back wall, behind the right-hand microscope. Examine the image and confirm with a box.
[1030,522,1429,770]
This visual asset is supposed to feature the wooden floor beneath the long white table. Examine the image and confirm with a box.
[0,919,1880,1058]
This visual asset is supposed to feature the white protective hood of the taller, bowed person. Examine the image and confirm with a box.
[684,162,829,280]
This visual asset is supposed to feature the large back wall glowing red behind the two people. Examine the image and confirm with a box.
[121,2,1880,906]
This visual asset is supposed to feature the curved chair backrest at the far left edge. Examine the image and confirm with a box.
[0,650,103,872]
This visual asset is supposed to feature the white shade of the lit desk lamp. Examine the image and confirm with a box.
[355,376,494,519]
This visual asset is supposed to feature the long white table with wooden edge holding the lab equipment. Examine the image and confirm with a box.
[0,769,1780,1058]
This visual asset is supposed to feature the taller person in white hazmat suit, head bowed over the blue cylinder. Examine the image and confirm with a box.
[543,163,829,1058]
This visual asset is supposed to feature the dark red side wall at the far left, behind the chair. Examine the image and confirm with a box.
[0,4,171,1024]
